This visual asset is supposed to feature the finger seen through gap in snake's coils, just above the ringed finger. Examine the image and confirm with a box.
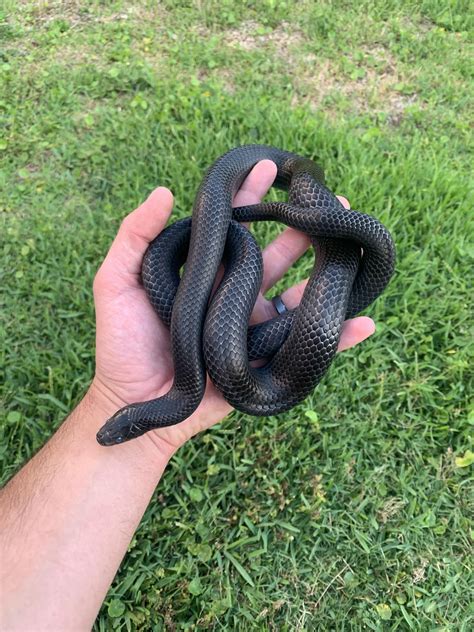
[262,228,311,294]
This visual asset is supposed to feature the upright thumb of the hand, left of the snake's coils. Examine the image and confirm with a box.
[102,187,173,275]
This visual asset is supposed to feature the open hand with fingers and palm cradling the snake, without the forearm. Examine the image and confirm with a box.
[91,160,375,455]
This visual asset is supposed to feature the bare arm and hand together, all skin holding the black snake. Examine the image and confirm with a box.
[0,160,375,632]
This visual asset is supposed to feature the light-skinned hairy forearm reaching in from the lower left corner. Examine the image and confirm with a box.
[0,389,171,631]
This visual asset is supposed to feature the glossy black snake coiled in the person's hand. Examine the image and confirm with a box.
[97,145,395,446]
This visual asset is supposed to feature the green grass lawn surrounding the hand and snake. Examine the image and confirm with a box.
[0,0,474,632]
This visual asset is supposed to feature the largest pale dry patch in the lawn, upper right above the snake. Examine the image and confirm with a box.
[199,20,423,121]
